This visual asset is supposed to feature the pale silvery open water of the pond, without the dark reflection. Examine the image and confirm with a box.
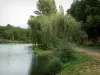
[0,44,32,75]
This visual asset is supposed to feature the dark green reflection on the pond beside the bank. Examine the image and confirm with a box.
[29,55,48,75]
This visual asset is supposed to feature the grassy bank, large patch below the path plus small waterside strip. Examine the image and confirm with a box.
[34,49,100,75]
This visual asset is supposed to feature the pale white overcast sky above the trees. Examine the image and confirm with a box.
[0,0,73,28]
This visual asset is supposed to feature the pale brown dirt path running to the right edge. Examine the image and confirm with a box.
[76,48,100,60]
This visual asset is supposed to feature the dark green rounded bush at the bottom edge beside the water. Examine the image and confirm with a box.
[45,58,62,75]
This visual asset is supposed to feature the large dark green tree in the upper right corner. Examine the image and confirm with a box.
[68,0,100,43]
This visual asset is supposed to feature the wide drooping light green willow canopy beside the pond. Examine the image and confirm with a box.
[28,13,84,47]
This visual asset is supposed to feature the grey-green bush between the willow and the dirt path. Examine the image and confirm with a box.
[54,44,74,63]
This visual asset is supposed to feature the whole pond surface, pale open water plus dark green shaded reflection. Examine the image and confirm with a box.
[0,44,48,75]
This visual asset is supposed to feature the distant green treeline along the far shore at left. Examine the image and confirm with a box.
[0,24,31,43]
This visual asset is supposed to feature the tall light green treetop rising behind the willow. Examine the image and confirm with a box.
[35,0,57,15]
